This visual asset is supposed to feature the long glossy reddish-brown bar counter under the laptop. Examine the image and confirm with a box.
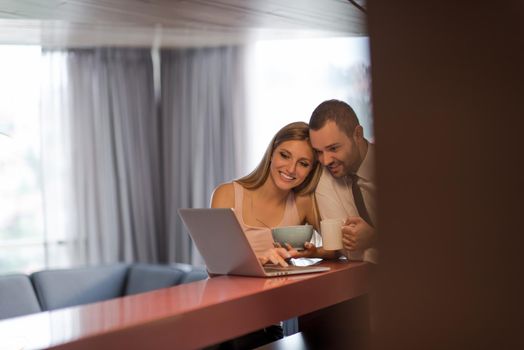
[0,260,372,350]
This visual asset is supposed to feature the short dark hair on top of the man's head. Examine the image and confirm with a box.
[309,100,360,137]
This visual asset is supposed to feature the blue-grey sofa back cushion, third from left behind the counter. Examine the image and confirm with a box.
[125,264,185,295]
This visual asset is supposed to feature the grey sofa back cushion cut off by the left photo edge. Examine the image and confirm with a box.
[0,274,41,319]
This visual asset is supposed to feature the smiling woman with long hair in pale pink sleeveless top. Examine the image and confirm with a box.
[211,122,321,266]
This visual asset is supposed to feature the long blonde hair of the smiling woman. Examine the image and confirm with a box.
[236,122,321,195]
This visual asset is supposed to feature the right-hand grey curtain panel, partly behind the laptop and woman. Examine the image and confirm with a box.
[160,47,245,264]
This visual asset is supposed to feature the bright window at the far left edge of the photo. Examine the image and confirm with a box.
[0,46,45,273]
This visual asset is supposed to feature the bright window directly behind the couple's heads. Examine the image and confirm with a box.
[244,37,373,174]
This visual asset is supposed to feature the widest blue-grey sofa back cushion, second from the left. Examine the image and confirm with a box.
[31,264,129,310]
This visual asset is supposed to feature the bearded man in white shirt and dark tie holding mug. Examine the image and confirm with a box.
[309,100,378,263]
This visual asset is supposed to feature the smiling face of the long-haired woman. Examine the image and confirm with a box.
[269,140,314,190]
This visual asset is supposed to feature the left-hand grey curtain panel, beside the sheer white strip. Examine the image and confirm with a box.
[43,48,163,264]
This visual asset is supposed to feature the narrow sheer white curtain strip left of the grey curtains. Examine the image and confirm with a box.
[40,51,76,267]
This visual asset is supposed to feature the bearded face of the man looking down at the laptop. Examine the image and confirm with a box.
[309,121,362,178]
